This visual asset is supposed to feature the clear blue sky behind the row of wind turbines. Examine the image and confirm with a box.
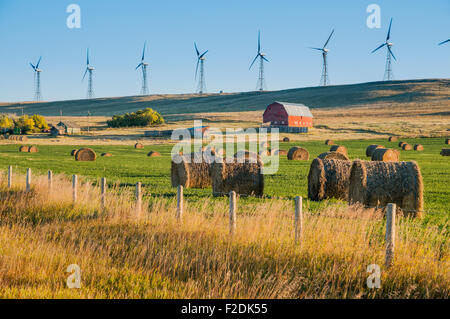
[0,0,450,102]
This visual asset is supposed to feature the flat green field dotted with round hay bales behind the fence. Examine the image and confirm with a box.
[0,138,450,225]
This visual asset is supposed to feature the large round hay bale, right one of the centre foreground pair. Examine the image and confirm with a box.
[211,158,264,196]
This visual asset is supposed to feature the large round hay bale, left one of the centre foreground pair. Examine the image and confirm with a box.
[170,152,213,188]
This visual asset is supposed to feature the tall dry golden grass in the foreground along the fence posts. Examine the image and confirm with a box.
[0,174,450,298]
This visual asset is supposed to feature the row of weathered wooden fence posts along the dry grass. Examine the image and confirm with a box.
[3,166,438,267]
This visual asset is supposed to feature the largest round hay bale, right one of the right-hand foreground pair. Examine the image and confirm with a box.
[349,160,423,217]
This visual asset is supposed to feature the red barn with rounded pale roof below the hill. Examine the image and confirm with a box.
[263,102,313,133]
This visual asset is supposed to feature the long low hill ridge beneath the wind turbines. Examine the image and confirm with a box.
[0,79,450,116]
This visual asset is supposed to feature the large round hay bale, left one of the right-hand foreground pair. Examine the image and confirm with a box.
[308,158,352,201]
